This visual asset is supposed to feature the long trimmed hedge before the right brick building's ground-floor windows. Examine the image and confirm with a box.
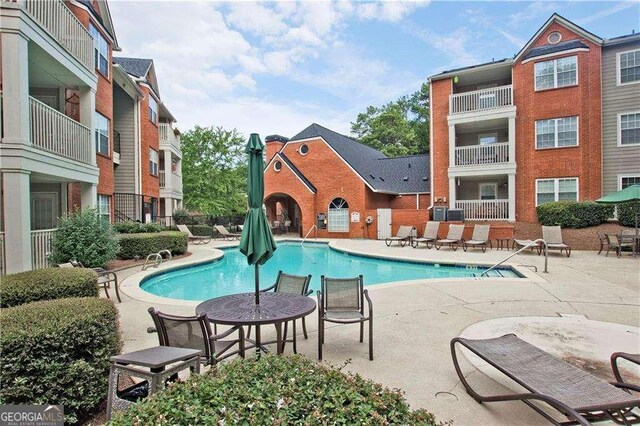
[536,201,614,228]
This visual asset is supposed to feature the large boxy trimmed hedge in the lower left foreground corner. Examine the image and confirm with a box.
[0,297,121,423]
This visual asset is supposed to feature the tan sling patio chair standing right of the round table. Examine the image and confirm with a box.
[318,275,373,361]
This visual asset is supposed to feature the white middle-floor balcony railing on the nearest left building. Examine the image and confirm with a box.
[29,96,93,164]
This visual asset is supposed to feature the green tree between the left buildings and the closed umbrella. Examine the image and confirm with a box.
[181,126,247,216]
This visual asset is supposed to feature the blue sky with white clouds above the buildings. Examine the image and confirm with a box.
[109,0,640,138]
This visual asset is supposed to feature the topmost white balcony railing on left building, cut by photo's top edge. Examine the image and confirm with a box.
[14,0,94,71]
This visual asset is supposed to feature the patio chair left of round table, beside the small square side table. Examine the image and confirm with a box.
[147,308,244,365]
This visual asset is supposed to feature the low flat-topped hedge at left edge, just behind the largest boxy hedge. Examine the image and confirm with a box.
[0,268,98,308]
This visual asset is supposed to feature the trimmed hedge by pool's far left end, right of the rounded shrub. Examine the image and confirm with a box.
[118,231,189,259]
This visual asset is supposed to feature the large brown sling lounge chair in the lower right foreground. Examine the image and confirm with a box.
[451,334,640,426]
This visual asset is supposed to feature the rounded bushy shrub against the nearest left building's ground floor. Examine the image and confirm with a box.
[51,209,118,268]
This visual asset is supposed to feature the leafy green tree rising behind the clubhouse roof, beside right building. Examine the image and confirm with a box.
[351,83,429,157]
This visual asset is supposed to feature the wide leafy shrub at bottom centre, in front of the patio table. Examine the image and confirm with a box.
[112,355,436,425]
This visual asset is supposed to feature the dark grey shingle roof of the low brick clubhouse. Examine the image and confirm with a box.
[290,123,430,194]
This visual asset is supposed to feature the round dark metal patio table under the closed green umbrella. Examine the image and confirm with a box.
[196,292,316,355]
